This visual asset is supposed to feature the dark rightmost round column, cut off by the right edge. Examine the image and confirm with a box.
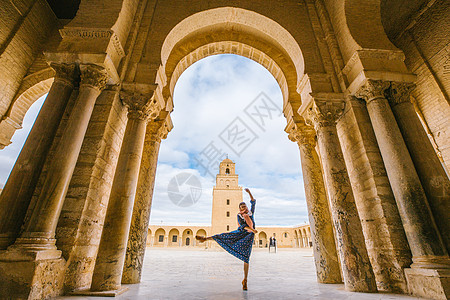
[387,82,450,253]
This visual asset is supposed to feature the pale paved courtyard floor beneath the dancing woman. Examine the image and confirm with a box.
[59,248,418,300]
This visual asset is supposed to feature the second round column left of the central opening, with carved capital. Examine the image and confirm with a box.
[91,90,160,292]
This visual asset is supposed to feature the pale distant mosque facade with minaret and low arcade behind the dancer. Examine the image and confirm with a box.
[147,158,312,248]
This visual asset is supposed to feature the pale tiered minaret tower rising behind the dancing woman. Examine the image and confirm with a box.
[211,158,242,234]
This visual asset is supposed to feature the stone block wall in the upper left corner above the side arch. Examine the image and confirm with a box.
[0,0,58,148]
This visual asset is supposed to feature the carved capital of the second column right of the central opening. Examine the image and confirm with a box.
[307,98,345,130]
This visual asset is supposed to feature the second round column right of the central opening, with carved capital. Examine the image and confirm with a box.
[308,99,377,292]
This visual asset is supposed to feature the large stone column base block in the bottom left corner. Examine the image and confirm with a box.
[0,249,66,299]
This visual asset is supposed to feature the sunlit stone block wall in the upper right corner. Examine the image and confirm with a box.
[390,0,450,172]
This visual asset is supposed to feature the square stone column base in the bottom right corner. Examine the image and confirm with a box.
[405,268,450,300]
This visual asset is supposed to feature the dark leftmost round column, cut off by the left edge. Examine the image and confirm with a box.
[0,63,76,249]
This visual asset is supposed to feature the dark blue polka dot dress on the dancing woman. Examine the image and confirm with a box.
[212,199,256,263]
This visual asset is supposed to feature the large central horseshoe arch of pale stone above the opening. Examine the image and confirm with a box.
[155,7,312,115]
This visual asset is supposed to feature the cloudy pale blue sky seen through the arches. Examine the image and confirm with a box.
[0,55,307,226]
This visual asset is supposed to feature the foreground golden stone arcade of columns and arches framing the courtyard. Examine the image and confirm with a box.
[0,0,450,299]
